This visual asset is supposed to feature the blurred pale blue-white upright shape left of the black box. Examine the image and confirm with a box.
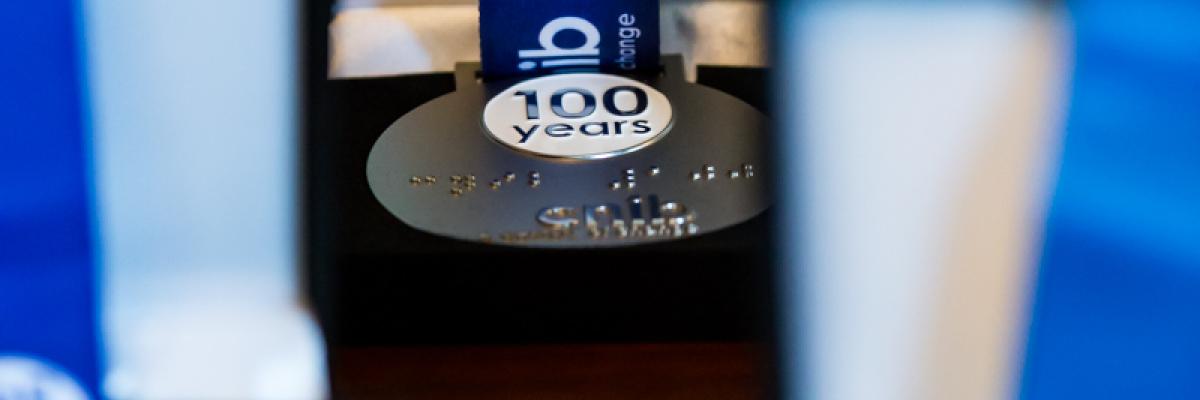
[84,0,325,399]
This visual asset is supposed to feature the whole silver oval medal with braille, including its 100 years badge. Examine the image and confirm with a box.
[366,61,768,247]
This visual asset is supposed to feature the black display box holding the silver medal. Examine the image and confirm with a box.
[305,66,772,346]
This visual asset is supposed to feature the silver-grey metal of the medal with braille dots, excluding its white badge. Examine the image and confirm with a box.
[366,58,768,247]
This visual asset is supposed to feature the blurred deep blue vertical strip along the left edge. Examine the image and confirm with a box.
[0,0,100,399]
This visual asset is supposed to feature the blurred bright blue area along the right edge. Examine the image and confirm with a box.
[1021,1,1200,399]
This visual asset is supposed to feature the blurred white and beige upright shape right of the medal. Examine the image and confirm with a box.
[775,1,1069,400]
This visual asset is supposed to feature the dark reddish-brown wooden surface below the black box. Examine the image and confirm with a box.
[330,344,772,400]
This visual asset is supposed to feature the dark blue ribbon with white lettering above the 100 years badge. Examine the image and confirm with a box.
[479,0,659,77]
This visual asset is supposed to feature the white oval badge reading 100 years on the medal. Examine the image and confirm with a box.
[484,73,674,160]
